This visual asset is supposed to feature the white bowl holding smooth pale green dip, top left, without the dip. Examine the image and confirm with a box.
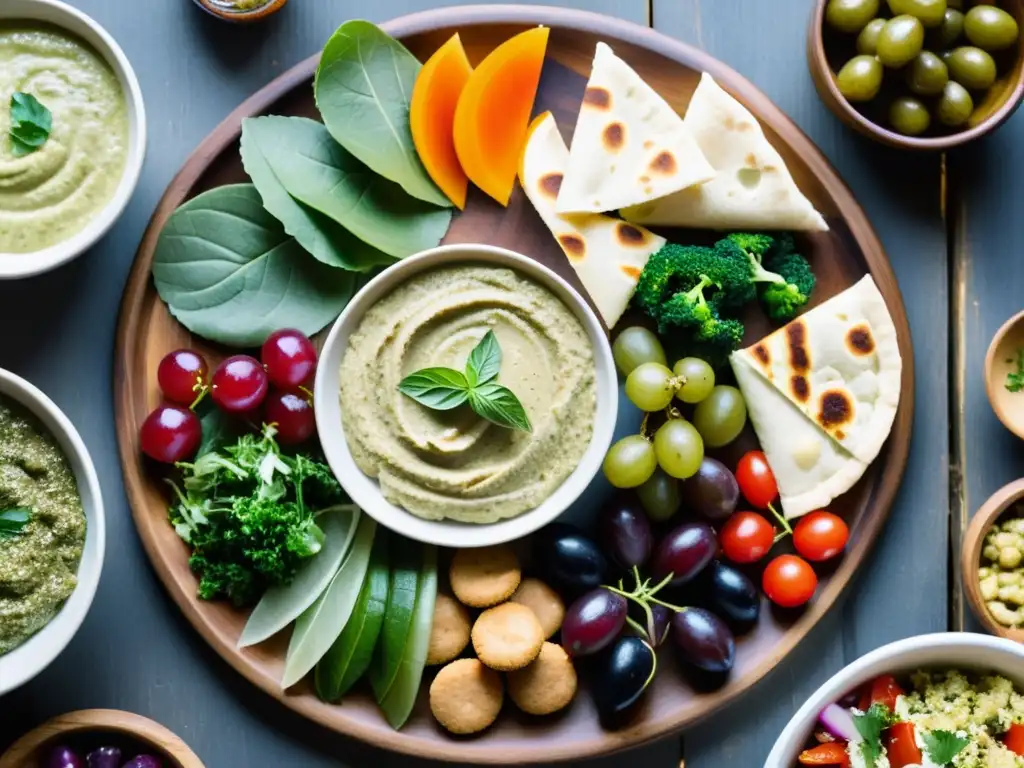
[0,0,145,280]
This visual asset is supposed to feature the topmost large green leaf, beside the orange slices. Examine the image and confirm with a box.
[313,20,452,208]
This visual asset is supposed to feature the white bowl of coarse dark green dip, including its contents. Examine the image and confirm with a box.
[0,369,105,695]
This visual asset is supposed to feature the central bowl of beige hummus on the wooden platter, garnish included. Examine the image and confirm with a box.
[313,245,618,547]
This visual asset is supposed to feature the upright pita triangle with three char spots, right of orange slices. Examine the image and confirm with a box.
[555,43,715,213]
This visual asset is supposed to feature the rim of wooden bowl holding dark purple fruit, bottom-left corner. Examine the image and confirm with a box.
[0,710,204,768]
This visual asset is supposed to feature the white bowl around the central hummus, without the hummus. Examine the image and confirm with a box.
[313,245,618,547]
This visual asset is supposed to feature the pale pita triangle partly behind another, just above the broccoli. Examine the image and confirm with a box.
[622,73,828,231]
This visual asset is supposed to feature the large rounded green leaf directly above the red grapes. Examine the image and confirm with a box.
[153,184,355,347]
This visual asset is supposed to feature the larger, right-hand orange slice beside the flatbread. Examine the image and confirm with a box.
[455,27,550,206]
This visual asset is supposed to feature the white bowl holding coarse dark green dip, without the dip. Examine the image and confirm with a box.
[0,369,106,695]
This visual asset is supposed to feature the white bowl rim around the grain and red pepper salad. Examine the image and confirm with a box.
[765,632,1024,768]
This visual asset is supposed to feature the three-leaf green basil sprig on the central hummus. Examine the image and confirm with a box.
[398,331,534,432]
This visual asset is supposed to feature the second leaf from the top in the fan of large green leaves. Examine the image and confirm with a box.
[242,116,452,259]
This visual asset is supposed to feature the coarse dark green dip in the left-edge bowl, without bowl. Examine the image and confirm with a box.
[0,395,85,654]
